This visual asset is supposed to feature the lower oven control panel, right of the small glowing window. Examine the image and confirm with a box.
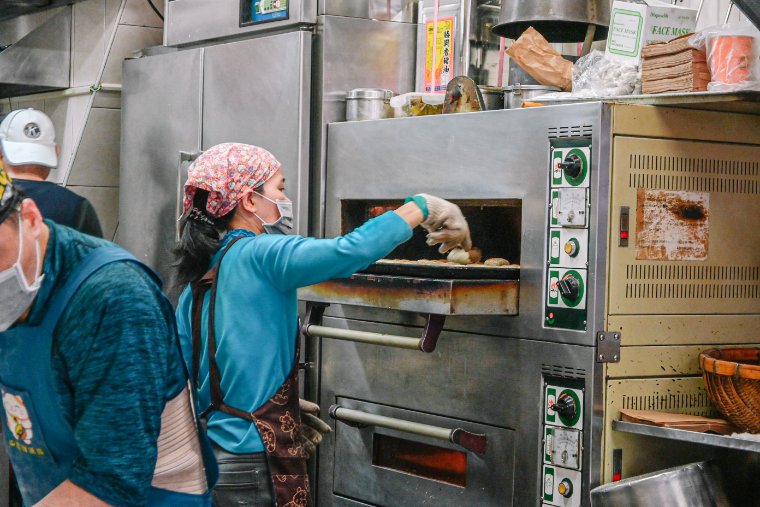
[541,378,584,507]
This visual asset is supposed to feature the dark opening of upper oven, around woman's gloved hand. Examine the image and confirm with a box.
[341,199,522,264]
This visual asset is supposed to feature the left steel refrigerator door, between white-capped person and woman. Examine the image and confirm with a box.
[118,49,203,289]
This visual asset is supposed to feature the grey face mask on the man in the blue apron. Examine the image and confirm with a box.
[0,213,43,333]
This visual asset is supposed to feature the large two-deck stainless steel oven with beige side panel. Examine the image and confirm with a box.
[300,103,760,507]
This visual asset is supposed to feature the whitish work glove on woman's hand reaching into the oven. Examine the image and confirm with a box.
[418,194,472,253]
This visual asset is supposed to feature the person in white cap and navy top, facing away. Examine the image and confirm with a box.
[0,109,103,238]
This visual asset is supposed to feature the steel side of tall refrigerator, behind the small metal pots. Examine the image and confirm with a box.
[309,14,417,237]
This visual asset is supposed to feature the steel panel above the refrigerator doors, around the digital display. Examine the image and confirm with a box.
[164,0,317,46]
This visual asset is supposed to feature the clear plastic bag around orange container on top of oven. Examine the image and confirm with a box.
[689,25,760,92]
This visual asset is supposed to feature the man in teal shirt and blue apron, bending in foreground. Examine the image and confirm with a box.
[0,169,216,507]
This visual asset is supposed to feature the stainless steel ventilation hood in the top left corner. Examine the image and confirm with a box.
[0,7,71,98]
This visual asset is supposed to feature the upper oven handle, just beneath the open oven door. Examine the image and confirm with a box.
[304,313,446,353]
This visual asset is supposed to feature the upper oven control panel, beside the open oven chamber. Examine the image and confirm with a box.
[544,139,591,331]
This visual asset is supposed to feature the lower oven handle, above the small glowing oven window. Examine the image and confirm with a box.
[329,405,488,456]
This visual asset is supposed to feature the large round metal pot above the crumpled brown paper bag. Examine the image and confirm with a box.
[493,0,610,42]
